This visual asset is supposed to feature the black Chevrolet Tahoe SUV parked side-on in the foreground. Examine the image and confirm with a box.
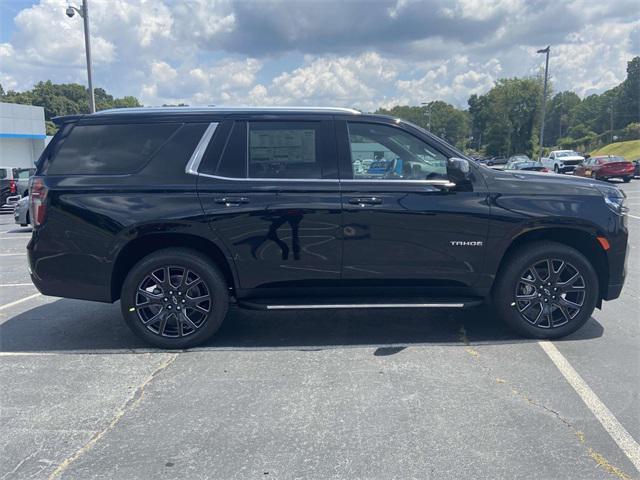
[28,108,627,348]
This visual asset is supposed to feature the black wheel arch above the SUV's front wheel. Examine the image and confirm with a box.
[494,227,609,306]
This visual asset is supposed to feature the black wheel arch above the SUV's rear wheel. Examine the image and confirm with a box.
[111,233,237,301]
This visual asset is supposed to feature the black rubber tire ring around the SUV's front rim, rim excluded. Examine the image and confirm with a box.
[493,242,599,338]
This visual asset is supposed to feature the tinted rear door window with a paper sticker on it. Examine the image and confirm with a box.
[248,122,322,179]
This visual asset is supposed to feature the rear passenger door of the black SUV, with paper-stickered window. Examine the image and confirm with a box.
[198,115,342,291]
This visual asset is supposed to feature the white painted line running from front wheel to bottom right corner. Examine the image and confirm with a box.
[538,340,640,471]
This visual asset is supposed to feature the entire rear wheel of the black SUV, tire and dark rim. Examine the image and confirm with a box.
[120,248,229,349]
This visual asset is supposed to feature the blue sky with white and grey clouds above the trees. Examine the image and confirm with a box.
[0,0,640,111]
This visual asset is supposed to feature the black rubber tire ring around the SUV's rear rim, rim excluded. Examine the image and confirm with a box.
[120,249,229,350]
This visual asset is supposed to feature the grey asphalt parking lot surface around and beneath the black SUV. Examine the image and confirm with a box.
[0,180,640,480]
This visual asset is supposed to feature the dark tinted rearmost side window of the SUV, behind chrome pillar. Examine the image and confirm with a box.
[48,123,180,175]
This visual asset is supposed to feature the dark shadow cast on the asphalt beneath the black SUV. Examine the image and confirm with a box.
[0,299,604,356]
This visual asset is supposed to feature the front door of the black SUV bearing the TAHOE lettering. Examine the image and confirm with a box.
[337,121,489,291]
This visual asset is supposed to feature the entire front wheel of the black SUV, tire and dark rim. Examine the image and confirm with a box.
[493,241,600,339]
